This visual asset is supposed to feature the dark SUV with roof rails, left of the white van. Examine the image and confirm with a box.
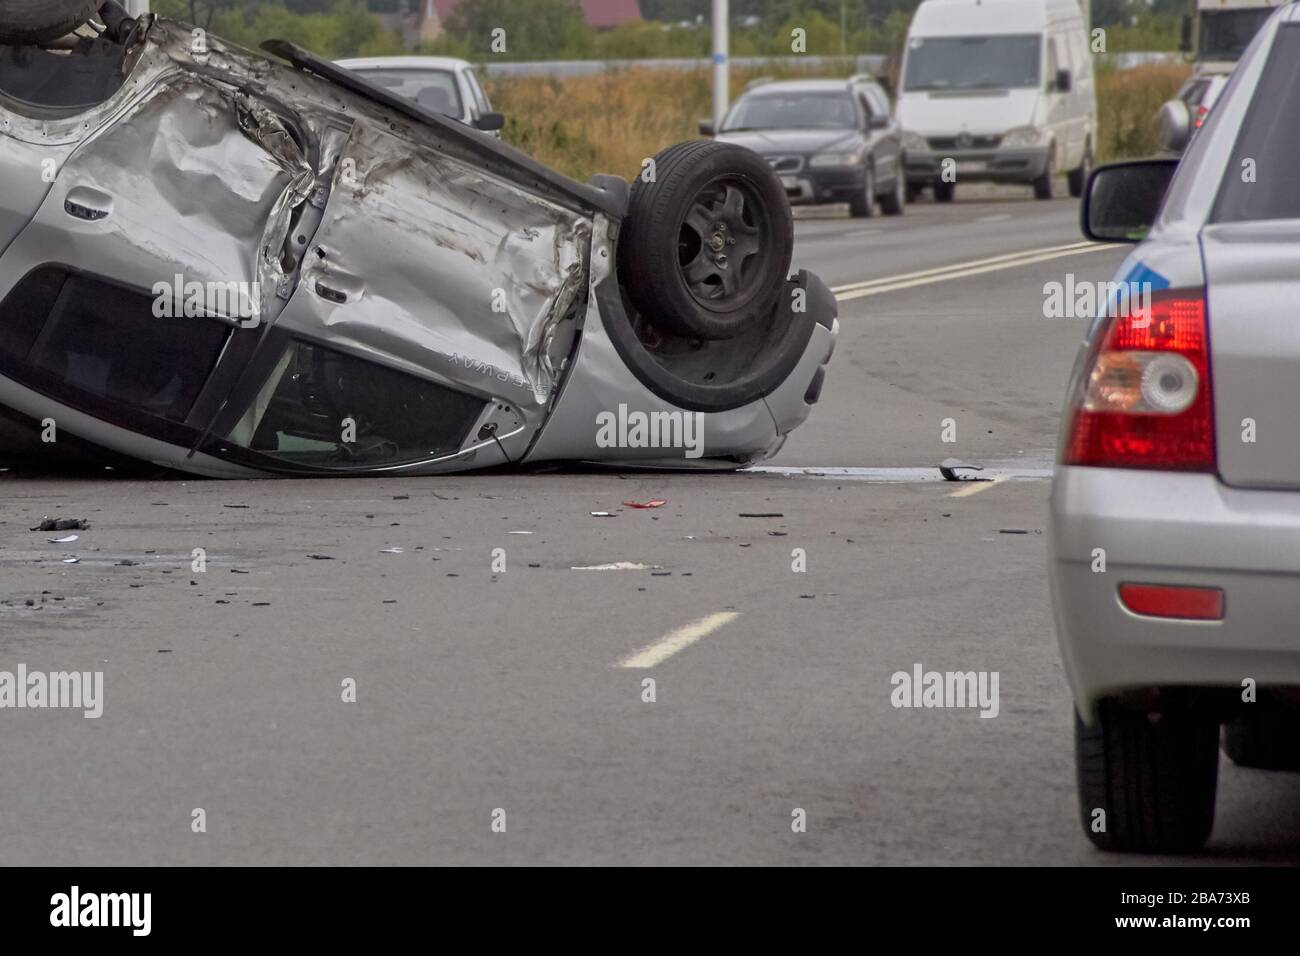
[699,75,907,217]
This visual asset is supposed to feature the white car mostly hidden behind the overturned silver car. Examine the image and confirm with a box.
[338,56,506,135]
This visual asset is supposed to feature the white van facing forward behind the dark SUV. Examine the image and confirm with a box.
[897,0,1097,202]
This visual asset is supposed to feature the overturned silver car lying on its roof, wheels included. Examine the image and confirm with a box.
[0,0,837,477]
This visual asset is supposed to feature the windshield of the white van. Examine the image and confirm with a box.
[902,34,1043,91]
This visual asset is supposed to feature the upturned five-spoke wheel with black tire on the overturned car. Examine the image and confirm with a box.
[619,140,794,339]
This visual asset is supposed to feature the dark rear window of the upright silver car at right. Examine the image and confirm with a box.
[1210,25,1300,222]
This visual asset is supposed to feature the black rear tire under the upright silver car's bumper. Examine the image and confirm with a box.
[1074,701,1218,853]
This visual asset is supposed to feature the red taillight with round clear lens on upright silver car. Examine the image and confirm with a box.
[1063,290,1214,471]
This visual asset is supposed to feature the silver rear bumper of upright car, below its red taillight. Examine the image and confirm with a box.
[1049,467,1300,719]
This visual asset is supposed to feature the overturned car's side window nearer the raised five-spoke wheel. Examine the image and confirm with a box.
[226,342,486,470]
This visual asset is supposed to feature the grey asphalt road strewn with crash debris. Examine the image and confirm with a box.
[0,191,1300,865]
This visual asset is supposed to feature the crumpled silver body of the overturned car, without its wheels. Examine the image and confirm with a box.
[0,18,836,477]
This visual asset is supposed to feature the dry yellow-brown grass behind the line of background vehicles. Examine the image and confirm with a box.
[489,65,1188,179]
